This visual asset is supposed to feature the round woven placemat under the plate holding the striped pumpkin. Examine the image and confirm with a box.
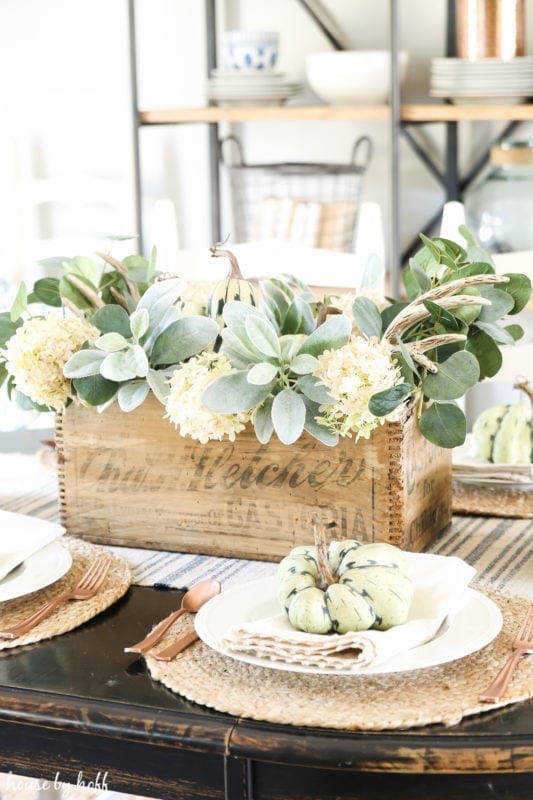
[146,590,533,730]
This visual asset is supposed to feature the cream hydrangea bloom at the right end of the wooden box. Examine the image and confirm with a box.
[314,335,401,440]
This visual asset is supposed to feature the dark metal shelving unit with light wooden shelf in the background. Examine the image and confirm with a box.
[128,0,533,294]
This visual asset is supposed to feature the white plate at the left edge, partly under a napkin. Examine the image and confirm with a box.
[0,542,72,603]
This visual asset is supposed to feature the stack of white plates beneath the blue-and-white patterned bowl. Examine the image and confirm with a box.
[207,69,302,106]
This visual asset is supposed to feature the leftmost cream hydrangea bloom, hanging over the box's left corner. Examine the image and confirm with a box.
[2,312,100,411]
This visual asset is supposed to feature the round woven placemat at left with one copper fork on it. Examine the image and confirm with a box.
[0,537,131,650]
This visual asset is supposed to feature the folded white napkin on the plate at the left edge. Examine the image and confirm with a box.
[0,509,65,581]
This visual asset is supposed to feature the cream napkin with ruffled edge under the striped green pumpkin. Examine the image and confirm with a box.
[220,553,475,673]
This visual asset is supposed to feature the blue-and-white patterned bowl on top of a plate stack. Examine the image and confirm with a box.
[221,30,279,72]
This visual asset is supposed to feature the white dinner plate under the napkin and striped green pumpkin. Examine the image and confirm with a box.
[195,576,502,677]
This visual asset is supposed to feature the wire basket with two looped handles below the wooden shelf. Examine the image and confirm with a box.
[219,136,372,252]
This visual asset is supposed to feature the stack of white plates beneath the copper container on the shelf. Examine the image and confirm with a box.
[430,56,533,104]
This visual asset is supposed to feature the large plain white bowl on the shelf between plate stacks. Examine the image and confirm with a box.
[306,50,409,105]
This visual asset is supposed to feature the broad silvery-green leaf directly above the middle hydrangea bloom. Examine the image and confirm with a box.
[150,316,219,366]
